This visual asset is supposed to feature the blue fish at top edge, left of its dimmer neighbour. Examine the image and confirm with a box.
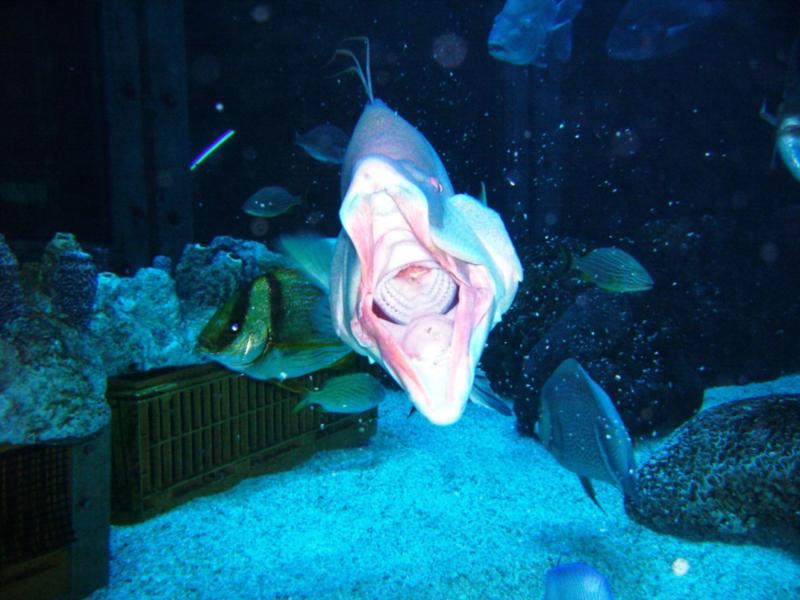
[489,0,583,68]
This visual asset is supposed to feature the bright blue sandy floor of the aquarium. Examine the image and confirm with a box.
[92,378,800,600]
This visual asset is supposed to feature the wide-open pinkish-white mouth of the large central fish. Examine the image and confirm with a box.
[340,157,493,425]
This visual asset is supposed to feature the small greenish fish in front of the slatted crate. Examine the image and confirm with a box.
[292,373,386,414]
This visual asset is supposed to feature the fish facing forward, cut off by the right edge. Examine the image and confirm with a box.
[760,37,800,181]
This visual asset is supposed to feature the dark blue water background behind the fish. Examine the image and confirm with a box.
[0,0,800,418]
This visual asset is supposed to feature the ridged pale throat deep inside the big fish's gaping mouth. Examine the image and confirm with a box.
[374,264,458,325]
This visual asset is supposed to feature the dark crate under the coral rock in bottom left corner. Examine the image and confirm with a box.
[0,428,110,600]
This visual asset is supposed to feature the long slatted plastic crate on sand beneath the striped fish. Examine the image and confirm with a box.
[106,364,377,523]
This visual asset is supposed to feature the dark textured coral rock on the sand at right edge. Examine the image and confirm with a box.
[625,395,800,550]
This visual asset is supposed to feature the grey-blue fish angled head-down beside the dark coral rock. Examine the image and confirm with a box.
[536,358,636,506]
